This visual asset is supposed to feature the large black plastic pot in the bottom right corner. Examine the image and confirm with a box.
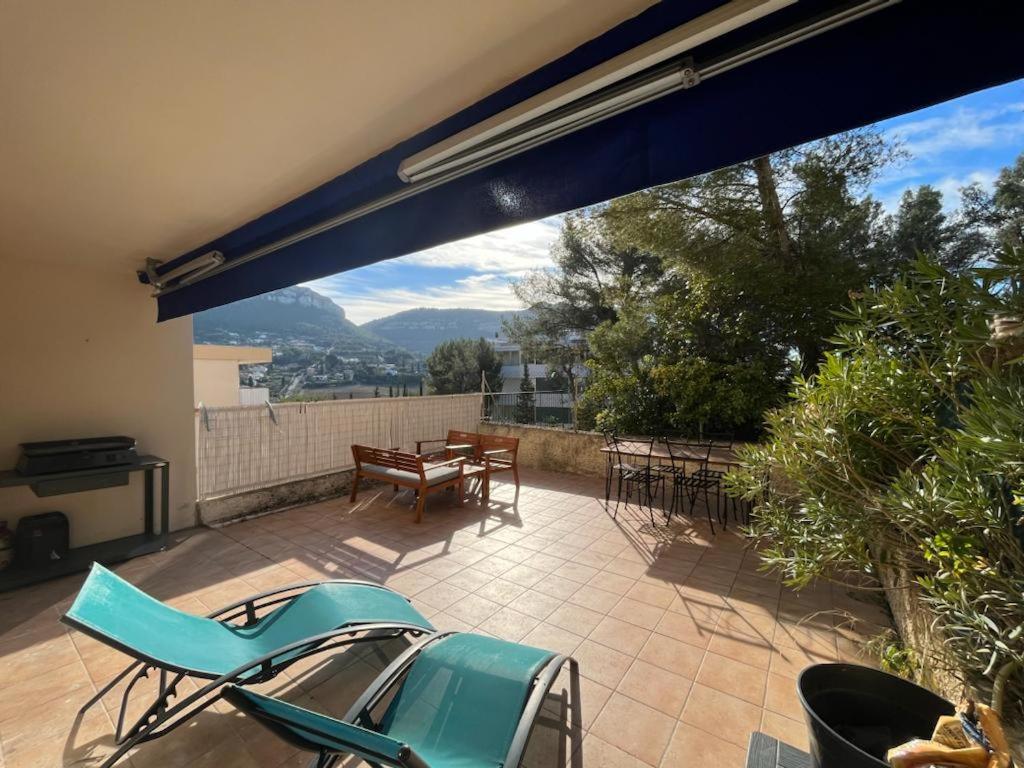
[797,664,953,768]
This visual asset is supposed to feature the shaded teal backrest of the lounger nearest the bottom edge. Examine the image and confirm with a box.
[225,685,404,766]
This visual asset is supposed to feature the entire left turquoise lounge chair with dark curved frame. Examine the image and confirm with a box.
[60,563,434,768]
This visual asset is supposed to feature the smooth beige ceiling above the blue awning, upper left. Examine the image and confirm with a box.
[0,0,652,269]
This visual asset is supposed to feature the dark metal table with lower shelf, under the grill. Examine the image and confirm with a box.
[0,456,170,592]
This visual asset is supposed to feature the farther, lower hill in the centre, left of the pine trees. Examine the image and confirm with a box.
[360,307,522,354]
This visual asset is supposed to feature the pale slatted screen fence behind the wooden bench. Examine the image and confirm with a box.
[196,394,482,501]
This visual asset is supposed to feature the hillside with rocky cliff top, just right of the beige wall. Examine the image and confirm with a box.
[193,287,395,356]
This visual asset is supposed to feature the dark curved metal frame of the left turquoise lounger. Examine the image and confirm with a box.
[60,579,433,768]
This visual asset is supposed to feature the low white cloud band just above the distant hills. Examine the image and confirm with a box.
[308,274,522,324]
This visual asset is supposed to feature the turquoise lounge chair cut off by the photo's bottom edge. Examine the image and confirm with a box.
[224,633,579,768]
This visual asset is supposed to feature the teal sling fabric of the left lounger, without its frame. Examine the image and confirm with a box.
[66,564,433,677]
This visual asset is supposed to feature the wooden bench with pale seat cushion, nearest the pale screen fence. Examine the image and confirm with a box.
[349,445,466,522]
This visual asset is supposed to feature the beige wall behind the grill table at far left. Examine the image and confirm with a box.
[0,255,196,546]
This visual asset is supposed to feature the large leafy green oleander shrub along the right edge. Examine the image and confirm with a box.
[727,250,1024,717]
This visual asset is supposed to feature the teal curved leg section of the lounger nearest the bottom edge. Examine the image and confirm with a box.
[381,634,555,768]
